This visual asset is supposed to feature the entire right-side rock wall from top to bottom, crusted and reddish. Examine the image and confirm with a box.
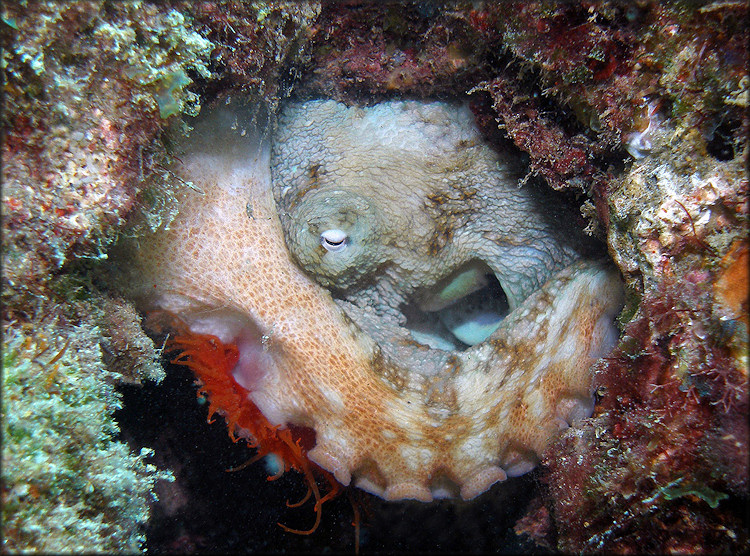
[468,2,748,552]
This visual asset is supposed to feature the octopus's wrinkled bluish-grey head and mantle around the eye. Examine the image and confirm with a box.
[271,100,596,368]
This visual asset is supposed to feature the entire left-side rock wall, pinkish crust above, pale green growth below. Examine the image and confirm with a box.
[0,1,211,552]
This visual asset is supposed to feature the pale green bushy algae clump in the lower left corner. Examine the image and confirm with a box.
[2,324,172,553]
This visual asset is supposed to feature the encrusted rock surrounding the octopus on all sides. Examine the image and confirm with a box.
[0,0,750,552]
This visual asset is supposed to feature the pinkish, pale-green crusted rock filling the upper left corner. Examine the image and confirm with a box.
[2,1,212,300]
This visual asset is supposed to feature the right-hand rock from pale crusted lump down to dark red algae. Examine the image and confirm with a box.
[536,93,748,551]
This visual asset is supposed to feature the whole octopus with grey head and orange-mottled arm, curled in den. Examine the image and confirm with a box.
[126,100,623,502]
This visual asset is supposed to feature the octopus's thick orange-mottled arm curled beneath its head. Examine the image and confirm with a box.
[128,102,622,501]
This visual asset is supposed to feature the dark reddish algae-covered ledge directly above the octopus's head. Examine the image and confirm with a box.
[300,2,489,101]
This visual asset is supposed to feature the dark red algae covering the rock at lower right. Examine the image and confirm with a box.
[544,270,748,553]
